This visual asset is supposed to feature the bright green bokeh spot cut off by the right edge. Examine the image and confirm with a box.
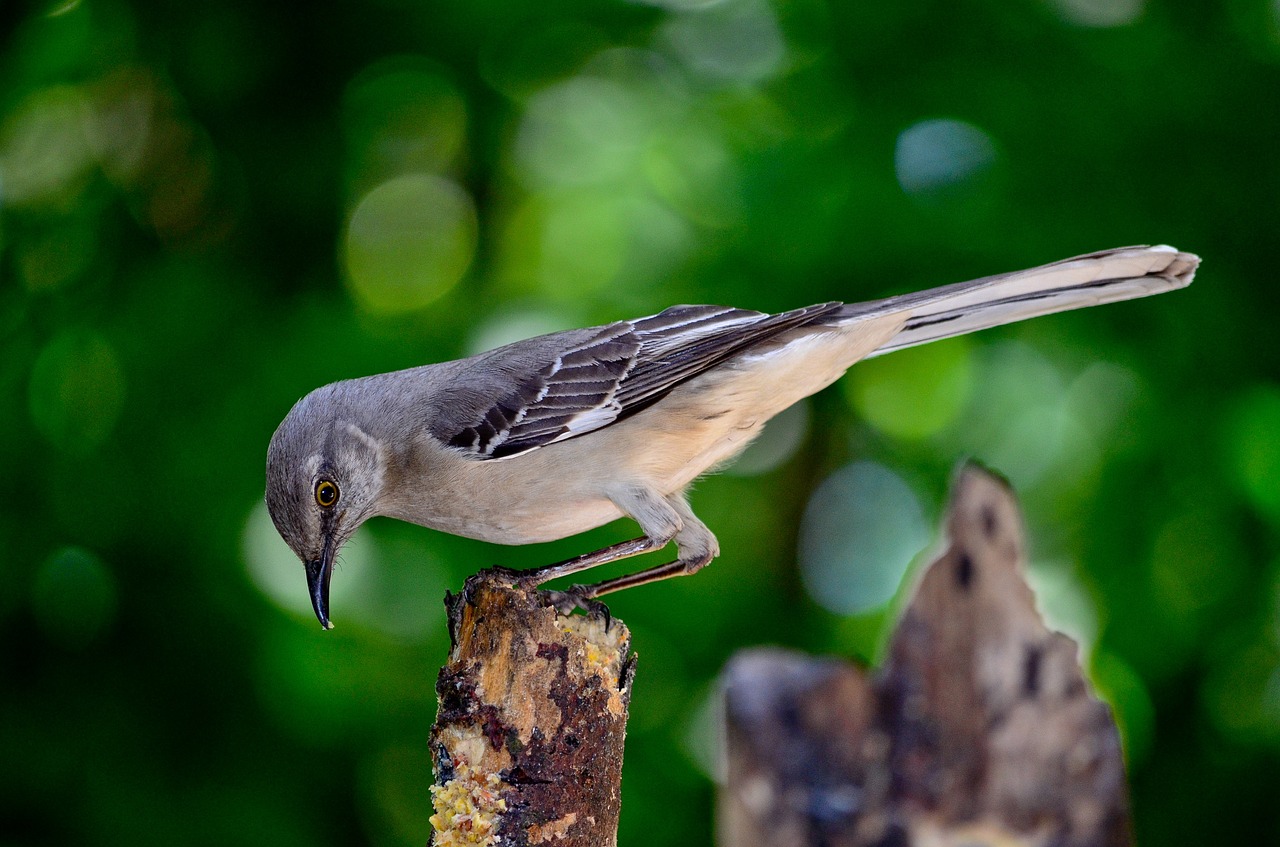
[1226,385,1280,525]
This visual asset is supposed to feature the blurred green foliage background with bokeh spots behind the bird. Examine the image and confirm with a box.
[0,0,1280,847]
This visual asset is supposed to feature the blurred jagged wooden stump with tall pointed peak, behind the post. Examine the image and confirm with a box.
[719,467,1132,847]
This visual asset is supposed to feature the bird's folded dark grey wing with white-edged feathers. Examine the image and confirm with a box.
[434,303,840,459]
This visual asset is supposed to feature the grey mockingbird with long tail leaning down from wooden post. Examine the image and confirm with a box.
[266,246,1199,629]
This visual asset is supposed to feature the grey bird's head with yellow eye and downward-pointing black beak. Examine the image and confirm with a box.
[266,386,387,629]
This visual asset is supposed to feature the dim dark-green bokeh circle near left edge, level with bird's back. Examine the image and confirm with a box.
[29,330,124,454]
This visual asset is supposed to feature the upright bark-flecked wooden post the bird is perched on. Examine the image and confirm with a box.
[431,574,635,847]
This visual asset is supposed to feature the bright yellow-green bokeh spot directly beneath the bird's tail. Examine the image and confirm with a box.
[844,338,973,439]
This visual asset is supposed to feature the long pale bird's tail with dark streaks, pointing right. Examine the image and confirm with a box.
[838,246,1199,356]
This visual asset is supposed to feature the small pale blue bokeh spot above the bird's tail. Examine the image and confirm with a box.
[893,118,997,197]
